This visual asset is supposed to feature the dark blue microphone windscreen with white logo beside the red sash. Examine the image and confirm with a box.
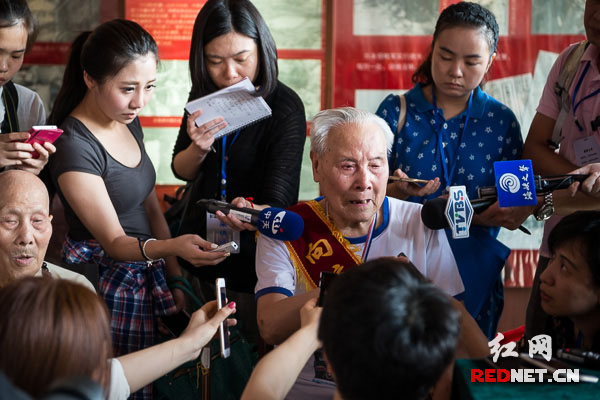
[256,207,304,240]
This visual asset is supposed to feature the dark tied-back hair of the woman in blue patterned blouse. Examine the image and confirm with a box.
[412,1,499,85]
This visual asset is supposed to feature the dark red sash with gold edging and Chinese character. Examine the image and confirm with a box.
[285,200,362,291]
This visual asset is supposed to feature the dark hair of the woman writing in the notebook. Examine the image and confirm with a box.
[190,0,279,99]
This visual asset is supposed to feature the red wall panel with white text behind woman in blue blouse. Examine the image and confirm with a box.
[333,0,585,107]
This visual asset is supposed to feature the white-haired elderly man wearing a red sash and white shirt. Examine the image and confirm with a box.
[255,107,464,398]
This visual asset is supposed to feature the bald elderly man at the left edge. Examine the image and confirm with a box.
[0,170,94,290]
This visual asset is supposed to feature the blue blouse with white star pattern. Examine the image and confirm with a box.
[377,84,523,203]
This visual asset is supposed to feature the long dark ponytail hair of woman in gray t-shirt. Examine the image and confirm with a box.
[48,19,158,126]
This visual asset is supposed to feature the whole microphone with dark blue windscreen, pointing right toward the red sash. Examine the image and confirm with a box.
[196,199,304,240]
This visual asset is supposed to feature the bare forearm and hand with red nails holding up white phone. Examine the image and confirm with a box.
[118,301,235,393]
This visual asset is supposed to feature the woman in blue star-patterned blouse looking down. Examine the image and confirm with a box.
[377,2,531,338]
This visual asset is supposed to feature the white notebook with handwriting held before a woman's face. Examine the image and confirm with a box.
[185,78,271,139]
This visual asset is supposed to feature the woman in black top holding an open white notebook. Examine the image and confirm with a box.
[172,0,306,344]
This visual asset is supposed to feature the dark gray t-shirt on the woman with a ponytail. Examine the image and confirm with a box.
[48,117,156,240]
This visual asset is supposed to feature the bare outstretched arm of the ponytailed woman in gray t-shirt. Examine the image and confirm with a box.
[58,171,225,266]
